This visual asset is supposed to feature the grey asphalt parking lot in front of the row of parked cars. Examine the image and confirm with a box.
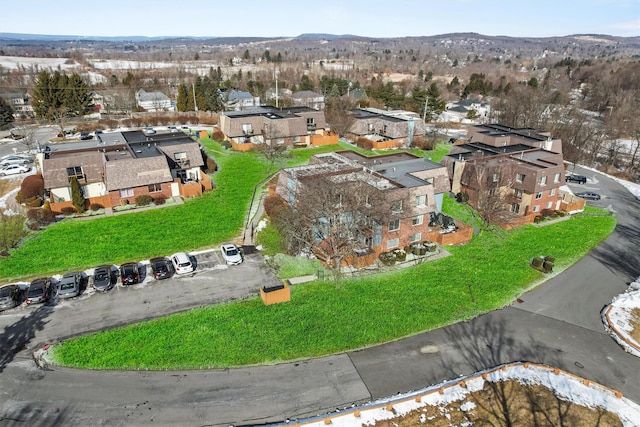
[0,247,279,345]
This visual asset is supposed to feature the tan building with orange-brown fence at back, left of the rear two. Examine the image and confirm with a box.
[220,106,338,151]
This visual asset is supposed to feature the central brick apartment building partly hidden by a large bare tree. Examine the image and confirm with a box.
[275,151,458,266]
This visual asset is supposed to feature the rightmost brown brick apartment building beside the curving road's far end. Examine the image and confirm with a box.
[441,124,566,228]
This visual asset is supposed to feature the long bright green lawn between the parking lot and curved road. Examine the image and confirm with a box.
[54,208,615,369]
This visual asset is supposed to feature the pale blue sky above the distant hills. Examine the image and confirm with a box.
[0,0,640,37]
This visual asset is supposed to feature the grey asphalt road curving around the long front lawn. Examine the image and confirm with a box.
[0,171,640,426]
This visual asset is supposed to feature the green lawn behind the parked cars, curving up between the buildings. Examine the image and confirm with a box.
[0,141,337,282]
